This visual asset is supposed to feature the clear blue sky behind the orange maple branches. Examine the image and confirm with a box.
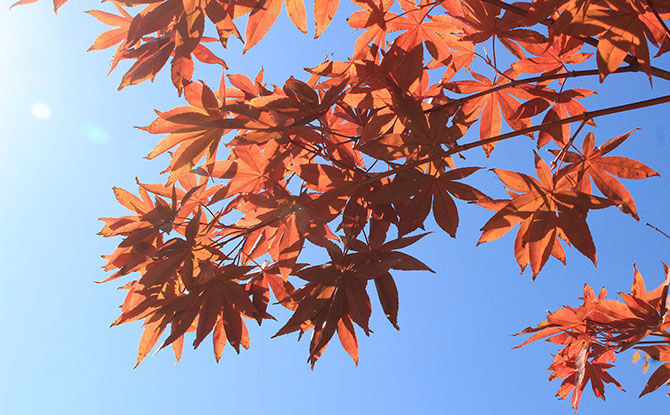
[0,1,670,415]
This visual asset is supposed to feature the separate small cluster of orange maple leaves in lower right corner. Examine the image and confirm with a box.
[517,264,670,409]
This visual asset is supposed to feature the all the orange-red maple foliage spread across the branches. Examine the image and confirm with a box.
[16,0,670,408]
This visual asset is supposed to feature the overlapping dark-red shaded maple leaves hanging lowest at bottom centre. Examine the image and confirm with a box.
[275,228,440,367]
